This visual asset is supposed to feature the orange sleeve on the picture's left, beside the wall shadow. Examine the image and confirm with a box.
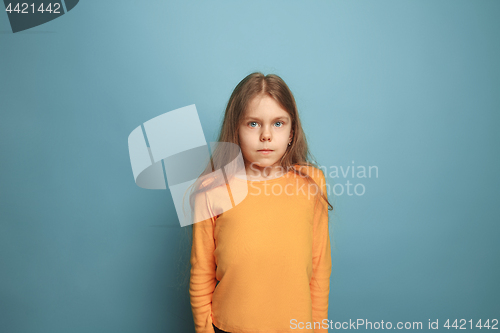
[189,188,217,333]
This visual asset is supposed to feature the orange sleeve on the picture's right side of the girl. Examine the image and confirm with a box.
[309,171,332,333]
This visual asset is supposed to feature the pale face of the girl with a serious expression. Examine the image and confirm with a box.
[238,95,293,175]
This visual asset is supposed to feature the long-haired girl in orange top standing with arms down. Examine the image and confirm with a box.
[189,72,333,333]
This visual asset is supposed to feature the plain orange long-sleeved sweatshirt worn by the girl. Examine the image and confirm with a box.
[189,167,332,333]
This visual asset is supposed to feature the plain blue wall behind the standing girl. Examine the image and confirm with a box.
[0,0,500,333]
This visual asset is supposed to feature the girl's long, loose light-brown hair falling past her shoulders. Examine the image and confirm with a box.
[175,72,333,288]
